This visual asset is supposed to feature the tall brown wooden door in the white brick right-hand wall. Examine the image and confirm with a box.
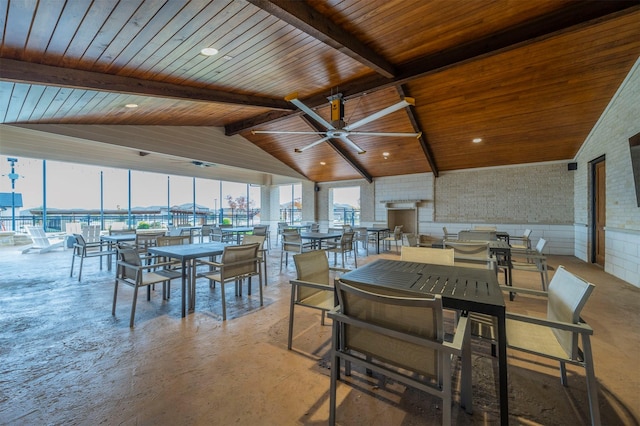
[591,156,607,268]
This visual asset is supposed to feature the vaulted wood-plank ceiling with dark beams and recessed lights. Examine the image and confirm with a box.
[0,0,640,182]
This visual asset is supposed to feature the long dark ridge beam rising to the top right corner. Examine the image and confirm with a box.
[225,0,640,135]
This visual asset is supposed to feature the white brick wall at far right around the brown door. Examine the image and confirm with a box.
[574,59,640,287]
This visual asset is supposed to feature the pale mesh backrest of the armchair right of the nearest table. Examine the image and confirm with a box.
[547,266,595,359]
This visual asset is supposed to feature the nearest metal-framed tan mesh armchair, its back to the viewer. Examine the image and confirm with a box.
[328,280,472,425]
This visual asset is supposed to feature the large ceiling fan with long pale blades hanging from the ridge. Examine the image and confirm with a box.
[251,93,422,154]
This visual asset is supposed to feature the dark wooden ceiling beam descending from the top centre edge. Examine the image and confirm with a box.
[248,0,396,78]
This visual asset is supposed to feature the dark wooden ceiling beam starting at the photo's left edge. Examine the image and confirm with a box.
[0,58,295,114]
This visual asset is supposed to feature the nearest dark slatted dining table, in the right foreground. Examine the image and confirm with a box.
[340,259,509,425]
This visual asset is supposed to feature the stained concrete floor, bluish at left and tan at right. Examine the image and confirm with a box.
[0,241,640,426]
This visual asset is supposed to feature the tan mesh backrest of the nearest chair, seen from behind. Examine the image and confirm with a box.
[336,280,444,381]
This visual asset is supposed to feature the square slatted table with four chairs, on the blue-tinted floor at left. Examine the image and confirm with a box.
[149,241,228,318]
